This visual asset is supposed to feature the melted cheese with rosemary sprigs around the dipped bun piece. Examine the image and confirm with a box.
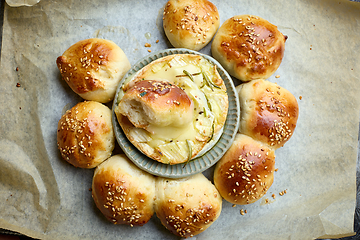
[119,55,227,163]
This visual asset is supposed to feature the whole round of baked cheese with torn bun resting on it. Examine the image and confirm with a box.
[114,54,229,164]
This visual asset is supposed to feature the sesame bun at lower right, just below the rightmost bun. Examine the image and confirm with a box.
[214,134,275,205]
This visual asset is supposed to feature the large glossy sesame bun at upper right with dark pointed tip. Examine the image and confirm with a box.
[211,15,287,82]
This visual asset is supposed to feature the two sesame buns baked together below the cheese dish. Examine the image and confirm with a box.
[92,154,222,237]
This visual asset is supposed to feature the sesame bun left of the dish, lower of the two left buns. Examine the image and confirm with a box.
[57,101,115,168]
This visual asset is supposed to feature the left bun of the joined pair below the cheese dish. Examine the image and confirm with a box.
[92,154,155,226]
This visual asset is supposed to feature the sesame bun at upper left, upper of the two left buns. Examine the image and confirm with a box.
[56,38,130,103]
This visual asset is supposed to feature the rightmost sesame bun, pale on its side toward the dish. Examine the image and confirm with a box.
[236,80,299,149]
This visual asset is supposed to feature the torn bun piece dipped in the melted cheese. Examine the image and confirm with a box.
[119,80,194,132]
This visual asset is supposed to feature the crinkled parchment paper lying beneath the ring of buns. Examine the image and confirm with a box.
[0,0,360,240]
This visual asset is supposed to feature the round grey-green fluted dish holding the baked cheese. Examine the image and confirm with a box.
[112,48,240,178]
